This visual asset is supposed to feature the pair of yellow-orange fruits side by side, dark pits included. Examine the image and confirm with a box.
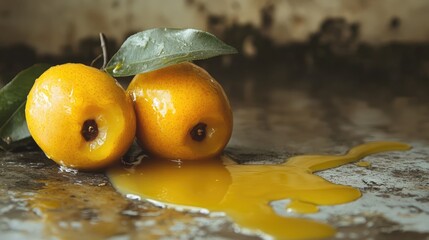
[25,62,232,170]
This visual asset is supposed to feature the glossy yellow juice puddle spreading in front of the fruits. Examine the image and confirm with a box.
[107,142,411,239]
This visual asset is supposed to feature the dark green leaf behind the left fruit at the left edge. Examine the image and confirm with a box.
[0,64,50,150]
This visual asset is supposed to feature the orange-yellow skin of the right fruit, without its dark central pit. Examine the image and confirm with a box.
[127,62,232,160]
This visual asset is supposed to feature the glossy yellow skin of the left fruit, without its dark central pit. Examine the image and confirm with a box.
[25,63,136,170]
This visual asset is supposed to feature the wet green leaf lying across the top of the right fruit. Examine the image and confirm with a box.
[105,28,237,77]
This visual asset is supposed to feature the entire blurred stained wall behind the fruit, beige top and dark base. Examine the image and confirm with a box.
[0,0,429,87]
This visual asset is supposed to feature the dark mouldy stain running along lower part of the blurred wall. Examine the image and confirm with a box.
[0,12,429,88]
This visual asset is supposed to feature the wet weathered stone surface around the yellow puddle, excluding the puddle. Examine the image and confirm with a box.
[0,64,429,239]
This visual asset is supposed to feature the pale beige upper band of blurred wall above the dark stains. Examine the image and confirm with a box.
[0,0,429,54]
